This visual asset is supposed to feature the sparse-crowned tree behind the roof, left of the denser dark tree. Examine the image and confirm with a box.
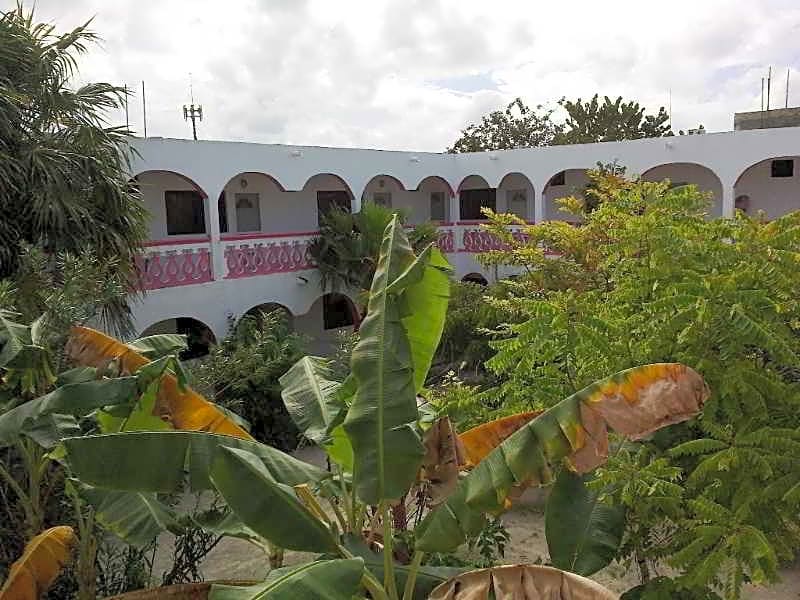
[447,98,562,153]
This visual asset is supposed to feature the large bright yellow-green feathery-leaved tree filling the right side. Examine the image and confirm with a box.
[476,172,800,598]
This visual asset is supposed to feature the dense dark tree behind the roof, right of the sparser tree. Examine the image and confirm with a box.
[554,94,672,144]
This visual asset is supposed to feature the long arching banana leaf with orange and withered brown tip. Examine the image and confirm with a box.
[416,363,709,552]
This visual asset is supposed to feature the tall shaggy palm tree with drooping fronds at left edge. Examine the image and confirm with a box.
[0,4,148,332]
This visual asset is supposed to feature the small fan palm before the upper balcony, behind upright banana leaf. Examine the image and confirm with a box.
[310,202,438,329]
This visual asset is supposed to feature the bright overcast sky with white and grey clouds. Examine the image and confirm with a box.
[17,0,800,151]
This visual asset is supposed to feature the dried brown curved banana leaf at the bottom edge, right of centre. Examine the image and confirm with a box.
[429,565,619,600]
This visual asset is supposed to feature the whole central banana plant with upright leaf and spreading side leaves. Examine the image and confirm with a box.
[64,219,707,600]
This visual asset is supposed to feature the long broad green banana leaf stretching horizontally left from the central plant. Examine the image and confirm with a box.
[64,431,330,492]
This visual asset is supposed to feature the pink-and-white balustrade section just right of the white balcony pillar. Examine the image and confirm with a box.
[223,232,316,279]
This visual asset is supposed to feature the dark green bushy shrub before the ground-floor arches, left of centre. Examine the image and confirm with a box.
[192,311,304,449]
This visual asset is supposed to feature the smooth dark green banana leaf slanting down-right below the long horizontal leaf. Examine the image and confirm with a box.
[211,447,337,552]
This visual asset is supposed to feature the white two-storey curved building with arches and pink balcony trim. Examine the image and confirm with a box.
[132,128,800,352]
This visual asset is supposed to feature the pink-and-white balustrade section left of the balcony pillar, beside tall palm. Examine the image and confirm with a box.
[136,239,213,290]
